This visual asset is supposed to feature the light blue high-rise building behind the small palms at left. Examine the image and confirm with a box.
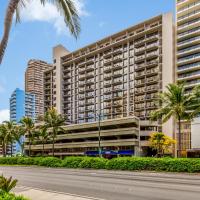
[10,88,35,154]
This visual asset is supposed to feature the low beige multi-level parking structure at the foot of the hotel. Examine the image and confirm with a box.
[25,117,140,156]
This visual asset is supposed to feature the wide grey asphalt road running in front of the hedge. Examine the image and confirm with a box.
[0,167,200,200]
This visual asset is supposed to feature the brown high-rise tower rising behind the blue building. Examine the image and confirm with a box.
[25,60,52,119]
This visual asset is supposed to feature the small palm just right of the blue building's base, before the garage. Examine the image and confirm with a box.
[20,117,35,156]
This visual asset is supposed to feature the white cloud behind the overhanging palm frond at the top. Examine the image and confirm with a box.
[21,0,89,34]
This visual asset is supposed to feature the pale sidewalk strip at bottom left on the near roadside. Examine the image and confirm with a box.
[14,186,103,200]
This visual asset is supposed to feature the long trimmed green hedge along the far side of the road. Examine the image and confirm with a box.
[0,157,200,172]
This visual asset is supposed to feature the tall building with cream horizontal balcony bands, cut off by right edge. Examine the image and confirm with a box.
[176,0,200,154]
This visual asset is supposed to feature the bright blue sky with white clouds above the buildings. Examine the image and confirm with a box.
[0,0,175,123]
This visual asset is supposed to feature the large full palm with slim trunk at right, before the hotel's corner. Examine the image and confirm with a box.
[151,83,199,157]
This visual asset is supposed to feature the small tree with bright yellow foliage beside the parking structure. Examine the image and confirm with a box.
[149,132,176,157]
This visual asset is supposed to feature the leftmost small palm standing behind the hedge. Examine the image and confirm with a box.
[4,121,16,157]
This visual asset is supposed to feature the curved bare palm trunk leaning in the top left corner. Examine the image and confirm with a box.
[0,0,20,64]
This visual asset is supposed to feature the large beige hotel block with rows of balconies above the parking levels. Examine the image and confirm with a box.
[39,13,175,156]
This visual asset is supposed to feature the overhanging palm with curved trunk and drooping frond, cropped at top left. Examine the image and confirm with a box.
[0,0,80,64]
